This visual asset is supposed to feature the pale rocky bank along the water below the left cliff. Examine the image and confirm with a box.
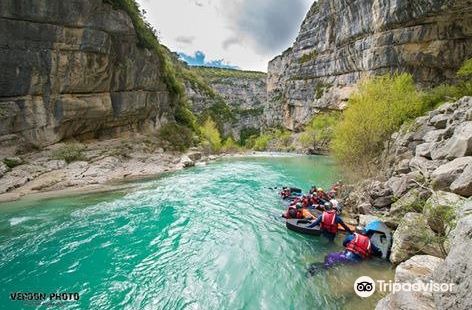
[0,134,230,202]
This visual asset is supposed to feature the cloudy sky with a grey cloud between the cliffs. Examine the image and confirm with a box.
[137,0,313,71]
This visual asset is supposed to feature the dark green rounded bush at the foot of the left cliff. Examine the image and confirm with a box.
[157,123,194,152]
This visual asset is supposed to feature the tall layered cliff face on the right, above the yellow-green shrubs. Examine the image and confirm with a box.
[265,0,472,130]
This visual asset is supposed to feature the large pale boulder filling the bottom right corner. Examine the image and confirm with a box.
[433,215,472,310]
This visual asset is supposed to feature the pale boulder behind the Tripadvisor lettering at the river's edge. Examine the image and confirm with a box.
[375,255,443,310]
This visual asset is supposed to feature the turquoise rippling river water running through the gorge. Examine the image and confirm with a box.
[0,156,393,310]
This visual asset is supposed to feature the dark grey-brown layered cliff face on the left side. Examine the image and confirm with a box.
[0,0,173,155]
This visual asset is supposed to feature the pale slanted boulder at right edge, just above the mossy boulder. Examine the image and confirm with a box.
[431,156,472,190]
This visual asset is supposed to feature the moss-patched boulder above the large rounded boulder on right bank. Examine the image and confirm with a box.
[423,191,464,234]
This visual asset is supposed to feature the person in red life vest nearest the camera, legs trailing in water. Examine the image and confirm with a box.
[324,226,382,269]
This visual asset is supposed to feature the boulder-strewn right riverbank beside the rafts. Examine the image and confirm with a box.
[345,97,472,309]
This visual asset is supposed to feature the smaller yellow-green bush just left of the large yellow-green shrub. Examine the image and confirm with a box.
[299,111,341,148]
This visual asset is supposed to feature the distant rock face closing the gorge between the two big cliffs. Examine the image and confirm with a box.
[186,68,267,141]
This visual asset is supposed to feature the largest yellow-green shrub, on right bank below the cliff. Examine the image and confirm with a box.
[332,73,424,176]
